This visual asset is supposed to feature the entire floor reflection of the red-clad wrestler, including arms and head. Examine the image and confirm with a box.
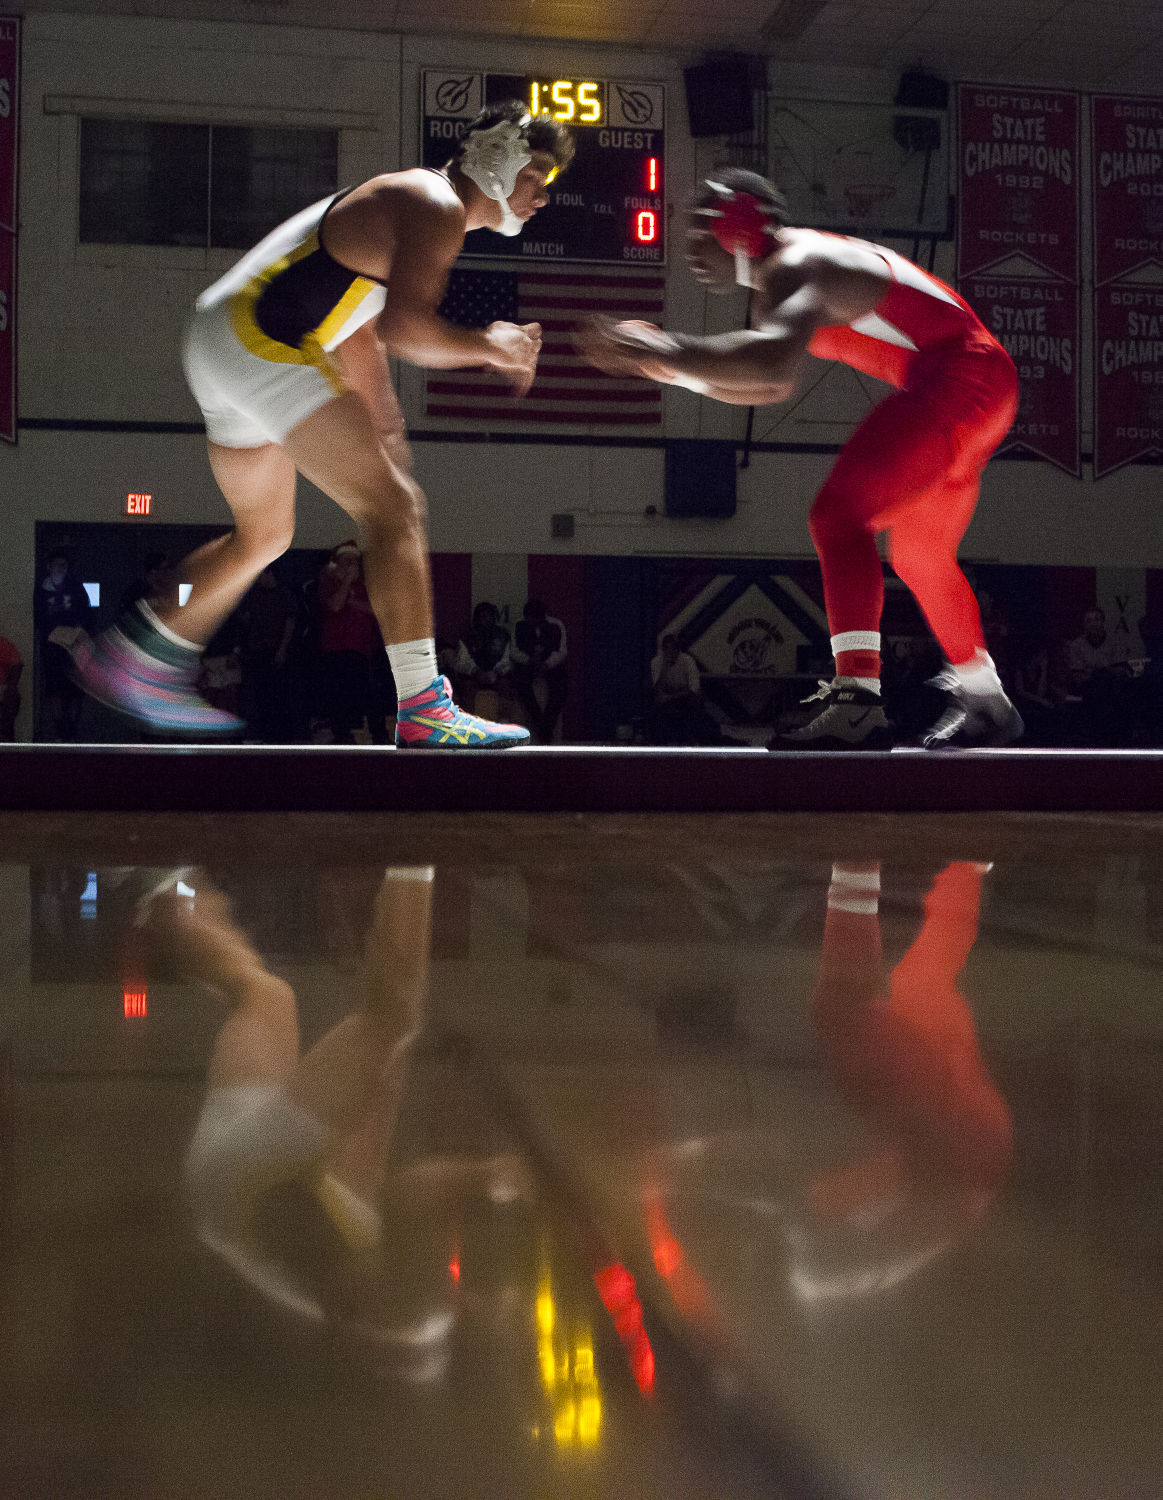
[642,863,1013,1326]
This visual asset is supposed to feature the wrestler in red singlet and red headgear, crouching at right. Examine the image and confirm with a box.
[579,168,1022,749]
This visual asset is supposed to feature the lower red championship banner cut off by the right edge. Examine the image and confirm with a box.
[1094,282,1163,479]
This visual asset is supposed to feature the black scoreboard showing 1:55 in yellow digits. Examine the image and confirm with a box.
[420,69,666,266]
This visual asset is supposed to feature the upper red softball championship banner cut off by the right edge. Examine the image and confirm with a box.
[1091,95,1163,287]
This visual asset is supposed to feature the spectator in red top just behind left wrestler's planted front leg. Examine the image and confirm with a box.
[318,542,387,744]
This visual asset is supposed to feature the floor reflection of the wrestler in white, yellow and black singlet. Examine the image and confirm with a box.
[137,869,452,1359]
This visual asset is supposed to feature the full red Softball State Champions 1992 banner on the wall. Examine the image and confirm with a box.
[957,84,1079,282]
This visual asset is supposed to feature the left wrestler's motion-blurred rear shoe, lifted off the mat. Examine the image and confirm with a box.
[72,609,245,738]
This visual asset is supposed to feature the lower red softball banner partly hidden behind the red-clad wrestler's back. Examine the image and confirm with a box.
[960,272,1082,479]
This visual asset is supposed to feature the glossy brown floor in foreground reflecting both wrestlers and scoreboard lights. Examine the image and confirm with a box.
[0,815,1163,1500]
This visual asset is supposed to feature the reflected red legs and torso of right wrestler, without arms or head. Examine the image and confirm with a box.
[794,863,1013,1296]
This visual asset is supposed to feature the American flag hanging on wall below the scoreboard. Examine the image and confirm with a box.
[425,267,666,428]
